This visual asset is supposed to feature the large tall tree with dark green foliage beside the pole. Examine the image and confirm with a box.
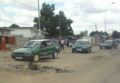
[34,3,73,36]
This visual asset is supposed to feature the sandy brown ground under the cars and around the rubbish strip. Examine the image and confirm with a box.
[0,47,120,83]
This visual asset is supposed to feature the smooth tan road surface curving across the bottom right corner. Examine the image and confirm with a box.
[46,48,120,83]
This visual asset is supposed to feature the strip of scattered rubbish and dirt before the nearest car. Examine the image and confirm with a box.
[0,64,73,75]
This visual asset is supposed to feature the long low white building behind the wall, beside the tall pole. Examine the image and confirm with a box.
[10,27,48,38]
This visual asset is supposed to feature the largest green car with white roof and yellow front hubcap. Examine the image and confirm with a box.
[11,39,60,62]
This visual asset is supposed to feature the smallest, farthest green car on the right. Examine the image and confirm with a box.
[100,40,118,49]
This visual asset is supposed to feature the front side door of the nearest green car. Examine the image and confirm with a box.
[39,41,48,57]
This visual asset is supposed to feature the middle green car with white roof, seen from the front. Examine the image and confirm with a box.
[72,39,92,53]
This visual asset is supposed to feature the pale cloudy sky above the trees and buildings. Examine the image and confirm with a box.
[0,0,120,34]
